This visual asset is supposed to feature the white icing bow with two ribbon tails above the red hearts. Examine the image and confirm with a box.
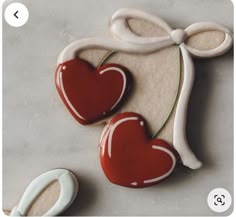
[58,8,233,169]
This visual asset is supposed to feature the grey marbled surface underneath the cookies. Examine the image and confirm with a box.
[3,0,233,215]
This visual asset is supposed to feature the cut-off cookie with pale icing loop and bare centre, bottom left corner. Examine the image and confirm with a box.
[10,169,79,216]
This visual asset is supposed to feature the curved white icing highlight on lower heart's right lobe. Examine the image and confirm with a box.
[143,145,176,184]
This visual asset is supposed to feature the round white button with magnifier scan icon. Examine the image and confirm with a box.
[207,188,232,212]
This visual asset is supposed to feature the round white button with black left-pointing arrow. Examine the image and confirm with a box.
[4,2,29,27]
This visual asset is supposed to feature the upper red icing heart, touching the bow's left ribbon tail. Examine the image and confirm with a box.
[55,58,131,125]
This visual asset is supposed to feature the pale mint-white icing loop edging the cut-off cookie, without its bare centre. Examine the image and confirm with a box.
[10,169,79,216]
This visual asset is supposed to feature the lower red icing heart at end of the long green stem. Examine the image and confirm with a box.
[99,112,177,188]
